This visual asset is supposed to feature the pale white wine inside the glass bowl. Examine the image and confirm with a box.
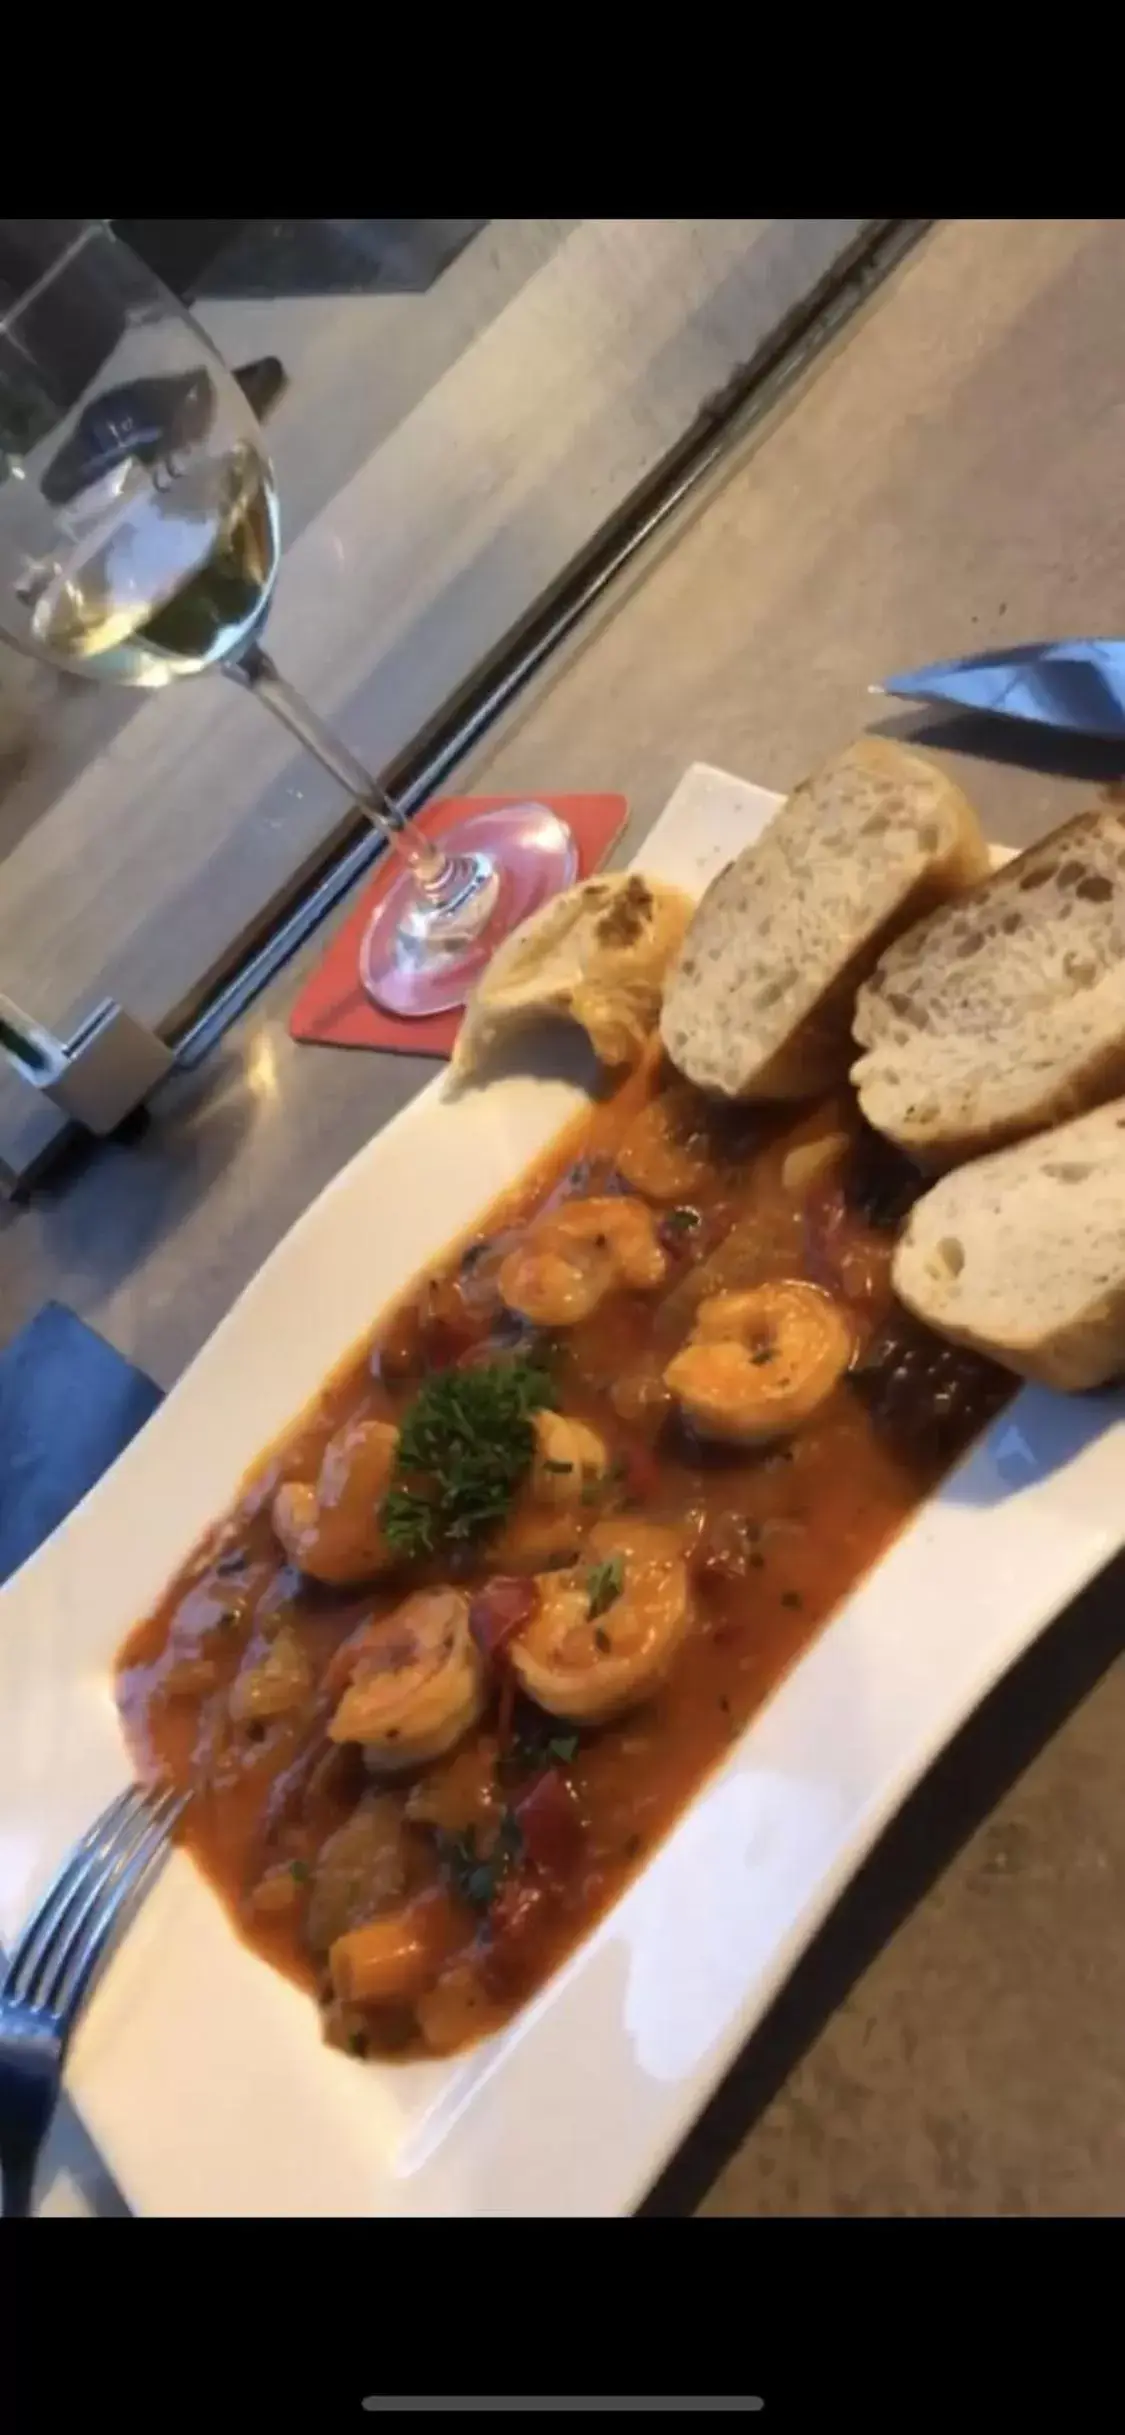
[29,443,278,687]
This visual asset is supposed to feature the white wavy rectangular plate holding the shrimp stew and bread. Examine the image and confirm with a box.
[0,765,1125,2216]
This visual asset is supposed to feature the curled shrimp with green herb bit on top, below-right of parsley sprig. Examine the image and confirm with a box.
[509,1515,692,1724]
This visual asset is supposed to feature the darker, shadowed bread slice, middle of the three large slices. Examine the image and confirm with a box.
[852,804,1125,1169]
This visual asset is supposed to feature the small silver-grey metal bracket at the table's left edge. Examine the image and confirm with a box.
[0,991,173,1135]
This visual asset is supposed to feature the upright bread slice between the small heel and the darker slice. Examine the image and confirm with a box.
[660,735,989,1101]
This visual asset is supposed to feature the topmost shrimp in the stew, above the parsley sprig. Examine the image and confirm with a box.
[499,1193,667,1327]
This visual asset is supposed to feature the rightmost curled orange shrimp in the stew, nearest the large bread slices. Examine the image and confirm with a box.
[665,1278,855,1446]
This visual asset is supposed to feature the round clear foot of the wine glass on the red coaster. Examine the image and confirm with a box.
[360,804,577,1015]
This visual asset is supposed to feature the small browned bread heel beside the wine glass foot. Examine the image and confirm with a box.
[453,872,692,1081]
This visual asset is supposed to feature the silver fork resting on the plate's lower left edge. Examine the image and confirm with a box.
[0,1785,188,2216]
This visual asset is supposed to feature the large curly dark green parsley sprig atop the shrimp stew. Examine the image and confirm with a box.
[382,1354,550,1556]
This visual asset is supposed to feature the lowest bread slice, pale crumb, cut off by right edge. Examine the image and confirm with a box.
[891,1098,1125,1393]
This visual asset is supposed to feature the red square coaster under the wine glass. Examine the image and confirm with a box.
[290,794,628,1057]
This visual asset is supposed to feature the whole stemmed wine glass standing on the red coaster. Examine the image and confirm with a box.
[0,219,577,1015]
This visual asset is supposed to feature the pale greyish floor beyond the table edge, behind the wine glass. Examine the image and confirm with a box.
[0,219,862,1169]
